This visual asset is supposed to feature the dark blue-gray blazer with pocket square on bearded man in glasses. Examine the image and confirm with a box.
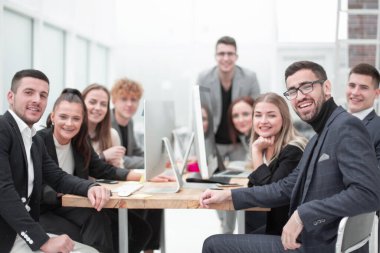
[232,107,380,252]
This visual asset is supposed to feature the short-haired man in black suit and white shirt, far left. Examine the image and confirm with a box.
[0,69,110,253]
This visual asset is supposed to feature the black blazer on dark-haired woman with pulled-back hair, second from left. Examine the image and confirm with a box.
[37,128,129,209]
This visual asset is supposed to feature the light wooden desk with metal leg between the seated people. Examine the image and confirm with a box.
[62,182,270,253]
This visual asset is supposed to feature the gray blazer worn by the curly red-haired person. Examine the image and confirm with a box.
[111,110,144,169]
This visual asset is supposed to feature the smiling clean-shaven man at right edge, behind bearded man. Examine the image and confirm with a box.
[346,63,380,164]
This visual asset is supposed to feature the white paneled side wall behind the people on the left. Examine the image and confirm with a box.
[0,0,116,122]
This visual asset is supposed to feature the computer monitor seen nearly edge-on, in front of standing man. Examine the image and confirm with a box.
[192,85,221,179]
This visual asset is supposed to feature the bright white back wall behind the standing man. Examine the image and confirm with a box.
[111,0,336,125]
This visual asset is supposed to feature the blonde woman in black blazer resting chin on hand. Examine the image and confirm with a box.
[246,93,307,235]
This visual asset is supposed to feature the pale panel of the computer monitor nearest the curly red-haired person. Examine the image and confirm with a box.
[144,100,175,180]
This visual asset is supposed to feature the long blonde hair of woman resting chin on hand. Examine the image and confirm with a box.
[250,92,307,161]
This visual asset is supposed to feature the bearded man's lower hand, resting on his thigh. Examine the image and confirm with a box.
[281,210,303,250]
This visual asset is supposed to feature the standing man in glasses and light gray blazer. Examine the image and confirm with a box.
[197,36,265,234]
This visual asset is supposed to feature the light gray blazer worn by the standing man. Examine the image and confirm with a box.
[197,66,260,133]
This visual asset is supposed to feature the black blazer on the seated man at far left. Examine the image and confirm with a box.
[0,112,92,252]
